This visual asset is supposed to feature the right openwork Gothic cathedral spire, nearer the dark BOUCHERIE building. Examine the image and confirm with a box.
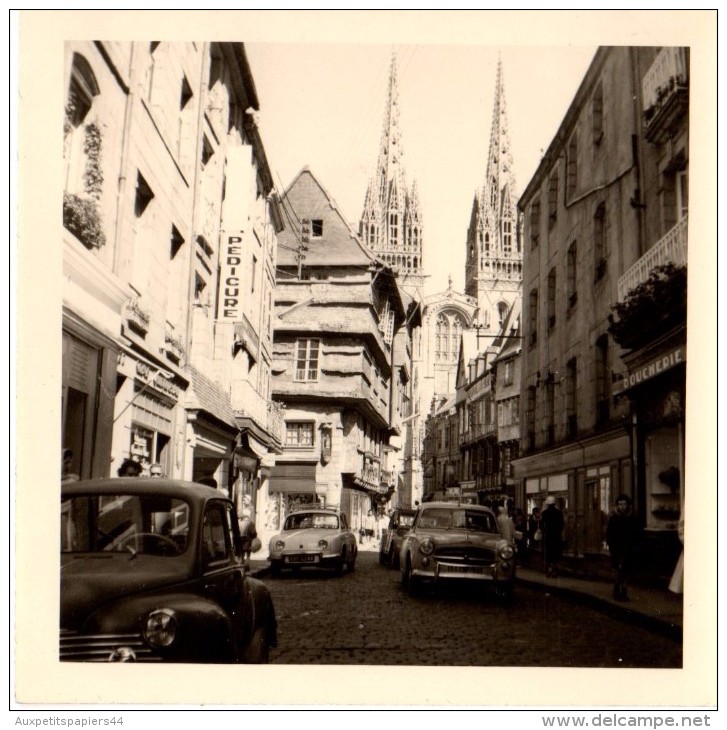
[465,61,523,334]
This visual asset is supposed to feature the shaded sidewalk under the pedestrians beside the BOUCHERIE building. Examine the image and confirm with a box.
[517,567,684,640]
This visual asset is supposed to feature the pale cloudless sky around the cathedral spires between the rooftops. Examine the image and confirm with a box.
[245,43,596,294]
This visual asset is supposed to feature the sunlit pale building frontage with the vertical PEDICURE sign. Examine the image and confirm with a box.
[62,41,282,512]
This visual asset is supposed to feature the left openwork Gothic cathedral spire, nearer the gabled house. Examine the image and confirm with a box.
[359,54,424,293]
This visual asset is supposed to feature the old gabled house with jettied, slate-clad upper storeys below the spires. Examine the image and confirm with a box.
[269,168,416,527]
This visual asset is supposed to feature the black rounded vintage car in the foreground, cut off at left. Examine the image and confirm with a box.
[60,478,277,664]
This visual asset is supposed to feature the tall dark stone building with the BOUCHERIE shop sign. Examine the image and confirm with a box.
[515,47,688,574]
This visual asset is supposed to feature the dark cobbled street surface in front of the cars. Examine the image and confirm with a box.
[265,550,682,668]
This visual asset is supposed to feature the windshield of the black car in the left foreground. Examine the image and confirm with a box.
[61,494,189,557]
